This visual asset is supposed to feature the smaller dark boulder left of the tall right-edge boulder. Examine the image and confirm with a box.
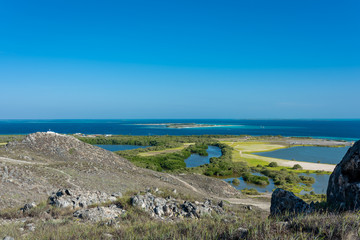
[270,188,313,216]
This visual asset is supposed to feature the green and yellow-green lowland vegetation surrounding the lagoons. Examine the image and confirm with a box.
[79,135,327,193]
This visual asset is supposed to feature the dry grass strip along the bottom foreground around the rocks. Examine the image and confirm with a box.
[0,202,360,240]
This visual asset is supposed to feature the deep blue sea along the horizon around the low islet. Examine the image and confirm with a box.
[0,119,360,141]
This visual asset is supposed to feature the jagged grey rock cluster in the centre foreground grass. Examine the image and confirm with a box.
[131,192,224,219]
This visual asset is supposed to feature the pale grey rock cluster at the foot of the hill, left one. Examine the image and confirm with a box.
[49,189,119,209]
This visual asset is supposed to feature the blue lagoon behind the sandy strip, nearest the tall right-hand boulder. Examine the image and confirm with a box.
[256,147,350,164]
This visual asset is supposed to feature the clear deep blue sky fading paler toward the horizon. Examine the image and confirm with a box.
[0,0,360,119]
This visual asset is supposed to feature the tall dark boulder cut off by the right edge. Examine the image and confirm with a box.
[327,141,360,210]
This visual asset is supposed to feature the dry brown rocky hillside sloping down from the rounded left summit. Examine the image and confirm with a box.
[0,133,239,208]
